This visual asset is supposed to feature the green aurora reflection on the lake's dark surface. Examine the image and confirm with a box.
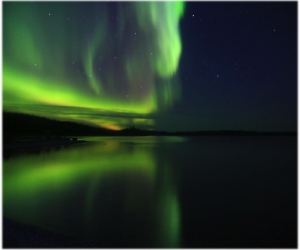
[3,137,180,248]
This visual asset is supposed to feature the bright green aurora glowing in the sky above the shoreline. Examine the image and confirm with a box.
[3,2,185,129]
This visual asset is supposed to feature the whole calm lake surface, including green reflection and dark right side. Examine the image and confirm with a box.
[3,136,297,248]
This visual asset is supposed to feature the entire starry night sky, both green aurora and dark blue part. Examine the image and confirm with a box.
[3,2,297,131]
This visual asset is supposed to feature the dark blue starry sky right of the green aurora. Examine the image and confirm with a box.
[158,2,297,131]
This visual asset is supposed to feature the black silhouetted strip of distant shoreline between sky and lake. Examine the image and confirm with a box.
[2,111,297,137]
